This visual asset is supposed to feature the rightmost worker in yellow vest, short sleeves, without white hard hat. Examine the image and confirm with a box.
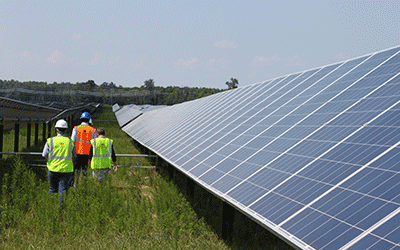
[89,128,117,182]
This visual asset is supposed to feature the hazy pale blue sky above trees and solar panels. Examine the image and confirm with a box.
[0,0,400,89]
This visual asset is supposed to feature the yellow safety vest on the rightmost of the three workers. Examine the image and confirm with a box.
[90,137,113,169]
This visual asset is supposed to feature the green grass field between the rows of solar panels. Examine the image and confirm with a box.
[0,107,289,249]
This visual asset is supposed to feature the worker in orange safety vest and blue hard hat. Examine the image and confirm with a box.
[71,112,97,186]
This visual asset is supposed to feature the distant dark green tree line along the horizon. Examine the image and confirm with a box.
[0,78,238,105]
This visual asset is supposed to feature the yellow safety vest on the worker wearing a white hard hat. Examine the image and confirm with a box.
[47,136,74,173]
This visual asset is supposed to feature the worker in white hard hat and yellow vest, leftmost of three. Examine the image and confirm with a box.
[42,119,75,203]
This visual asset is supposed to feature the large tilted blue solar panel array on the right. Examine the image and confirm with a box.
[123,47,400,249]
